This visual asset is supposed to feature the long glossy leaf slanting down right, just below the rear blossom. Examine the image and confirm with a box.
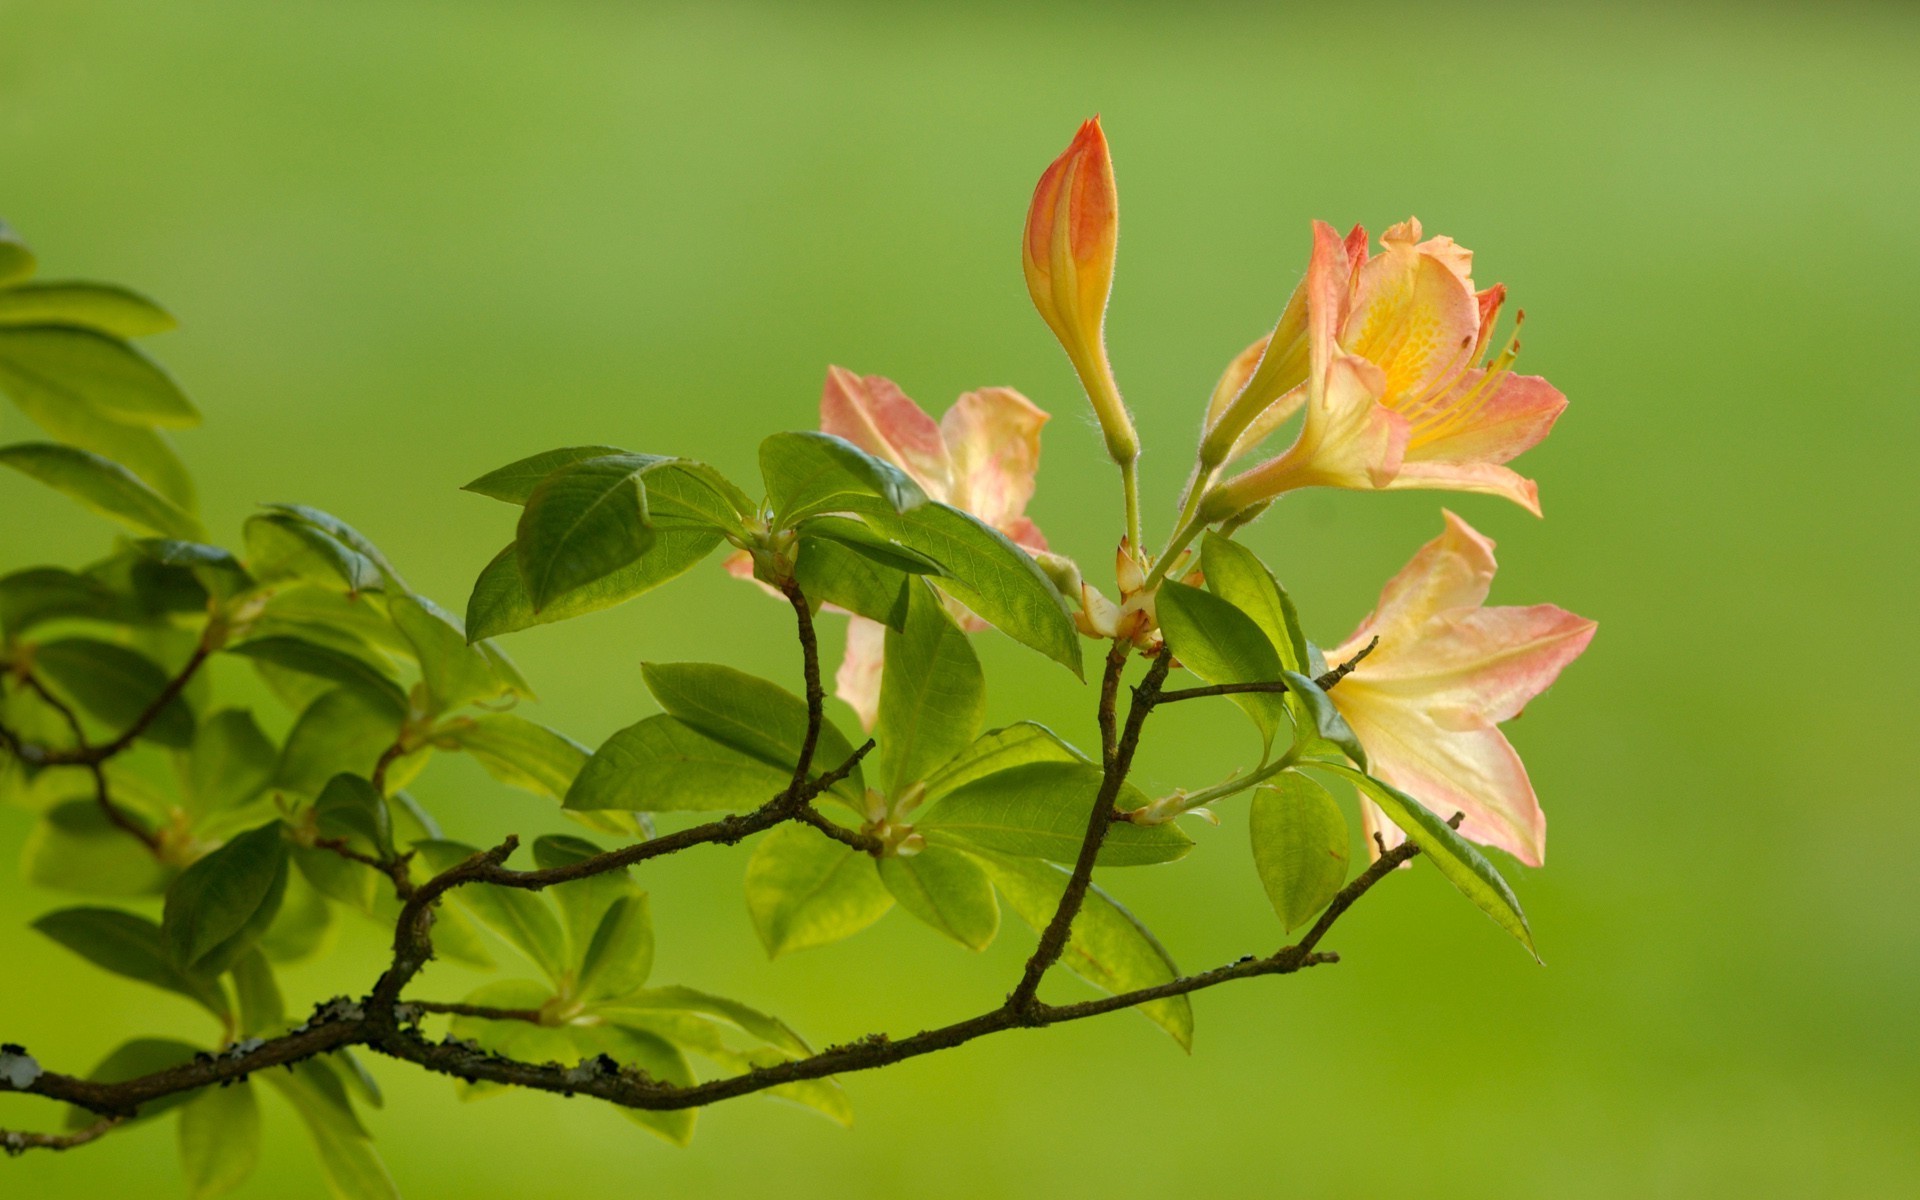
[864,503,1083,676]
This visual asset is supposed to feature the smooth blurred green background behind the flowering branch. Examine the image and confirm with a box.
[0,0,1920,1200]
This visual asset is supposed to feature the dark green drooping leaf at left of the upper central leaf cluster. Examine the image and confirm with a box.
[513,455,668,612]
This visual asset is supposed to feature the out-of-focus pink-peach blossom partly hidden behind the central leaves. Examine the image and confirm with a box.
[728,367,1048,730]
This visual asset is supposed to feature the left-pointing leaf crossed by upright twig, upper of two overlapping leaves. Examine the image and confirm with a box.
[639,662,866,810]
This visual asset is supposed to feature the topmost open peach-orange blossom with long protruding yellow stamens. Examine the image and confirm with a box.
[1200,219,1567,518]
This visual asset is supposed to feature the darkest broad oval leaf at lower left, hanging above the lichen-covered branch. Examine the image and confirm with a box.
[159,820,288,973]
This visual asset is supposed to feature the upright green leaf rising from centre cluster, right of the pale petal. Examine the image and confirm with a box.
[874,584,987,797]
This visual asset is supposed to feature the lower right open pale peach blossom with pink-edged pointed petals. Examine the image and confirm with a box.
[1327,513,1596,866]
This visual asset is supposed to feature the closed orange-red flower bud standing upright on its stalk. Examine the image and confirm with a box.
[1020,117,1140,467]
